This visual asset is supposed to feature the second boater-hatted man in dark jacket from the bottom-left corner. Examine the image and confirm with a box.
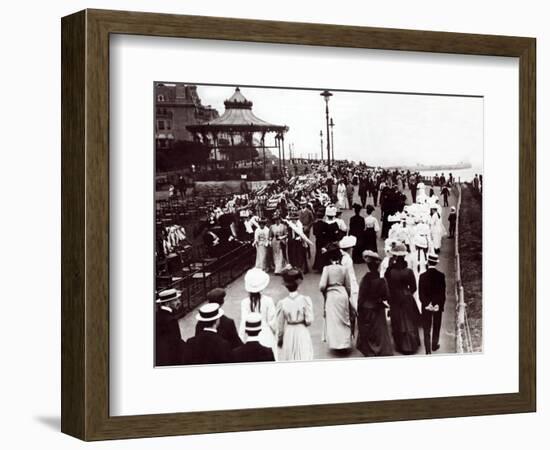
[187,303,232,364]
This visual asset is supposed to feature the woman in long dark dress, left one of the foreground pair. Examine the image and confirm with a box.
[357,250,393,356]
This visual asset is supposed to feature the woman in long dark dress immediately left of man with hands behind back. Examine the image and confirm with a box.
[384,244,420,355]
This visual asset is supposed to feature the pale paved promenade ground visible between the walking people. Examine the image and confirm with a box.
[179,188,456,359]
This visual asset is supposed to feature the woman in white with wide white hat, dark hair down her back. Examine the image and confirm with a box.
[239,268,277,360]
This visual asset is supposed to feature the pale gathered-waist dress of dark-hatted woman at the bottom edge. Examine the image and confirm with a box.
[277,292,313,361]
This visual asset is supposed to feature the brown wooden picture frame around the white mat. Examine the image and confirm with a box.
[61,10,536,440]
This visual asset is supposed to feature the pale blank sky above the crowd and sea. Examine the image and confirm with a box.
[192,85,483,169]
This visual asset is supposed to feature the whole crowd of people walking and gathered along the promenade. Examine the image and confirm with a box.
[156,163,456,365]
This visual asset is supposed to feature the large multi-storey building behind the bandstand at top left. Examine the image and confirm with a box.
[155,83,219,150]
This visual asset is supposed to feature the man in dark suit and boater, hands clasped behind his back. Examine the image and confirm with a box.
[418,254,446,355]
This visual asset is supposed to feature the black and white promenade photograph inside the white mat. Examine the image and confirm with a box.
[152,81,484,367]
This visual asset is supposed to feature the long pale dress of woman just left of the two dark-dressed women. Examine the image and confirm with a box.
[319,264,351,350]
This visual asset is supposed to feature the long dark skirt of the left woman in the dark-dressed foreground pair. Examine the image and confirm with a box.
[357,307,393,356]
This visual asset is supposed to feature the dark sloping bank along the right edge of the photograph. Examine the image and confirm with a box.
[458,184,483,352]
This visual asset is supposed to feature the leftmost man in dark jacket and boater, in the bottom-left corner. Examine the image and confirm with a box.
[155,289,188,366]
